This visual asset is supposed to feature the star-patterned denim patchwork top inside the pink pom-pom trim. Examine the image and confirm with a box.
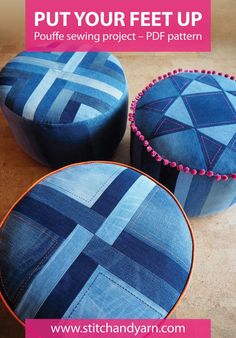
[135,71,236,179]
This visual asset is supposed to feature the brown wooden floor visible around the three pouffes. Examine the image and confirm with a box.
[0,0,236,338]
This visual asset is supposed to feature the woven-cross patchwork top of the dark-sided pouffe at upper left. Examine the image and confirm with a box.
[0,52,127,124]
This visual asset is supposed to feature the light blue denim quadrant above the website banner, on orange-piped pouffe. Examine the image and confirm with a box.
[63,266,167,319]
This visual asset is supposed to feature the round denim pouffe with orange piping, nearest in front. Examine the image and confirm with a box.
[0,162,194,321]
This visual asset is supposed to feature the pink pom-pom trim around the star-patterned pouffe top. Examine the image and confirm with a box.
[129,68,236,182]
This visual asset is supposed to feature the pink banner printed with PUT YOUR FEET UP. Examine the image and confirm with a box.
[26,0,211,52]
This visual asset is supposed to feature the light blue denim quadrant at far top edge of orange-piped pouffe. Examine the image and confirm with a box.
[40,163,126,207]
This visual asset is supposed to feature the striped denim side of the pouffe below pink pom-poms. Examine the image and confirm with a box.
[130,133,236,217]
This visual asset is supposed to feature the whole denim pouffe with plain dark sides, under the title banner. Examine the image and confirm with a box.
[0,52,128,168]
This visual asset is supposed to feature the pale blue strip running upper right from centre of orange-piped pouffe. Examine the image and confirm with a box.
[96,176,156,245]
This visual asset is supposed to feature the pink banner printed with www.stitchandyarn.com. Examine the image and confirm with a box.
[26,319,211,338]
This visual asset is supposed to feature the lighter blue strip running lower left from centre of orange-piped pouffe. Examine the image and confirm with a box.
[15,225,93,320]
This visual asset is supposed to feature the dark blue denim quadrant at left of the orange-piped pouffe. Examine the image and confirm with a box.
[0,211,62,308]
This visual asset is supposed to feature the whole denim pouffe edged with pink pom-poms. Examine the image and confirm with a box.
[129,69,236,217]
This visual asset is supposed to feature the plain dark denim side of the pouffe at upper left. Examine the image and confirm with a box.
[2,93,128,168]
